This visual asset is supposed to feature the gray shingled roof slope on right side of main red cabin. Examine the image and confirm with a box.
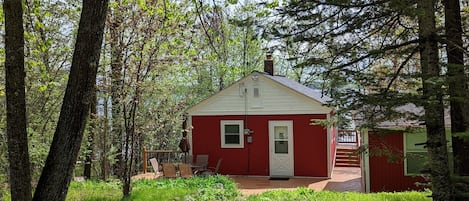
[260,73,332,104]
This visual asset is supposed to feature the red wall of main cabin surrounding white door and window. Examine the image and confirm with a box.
[192,115,327,177]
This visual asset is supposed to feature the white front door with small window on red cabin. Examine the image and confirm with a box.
[269,121,293,177]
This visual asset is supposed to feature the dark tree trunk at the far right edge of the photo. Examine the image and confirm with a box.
[444,0,469,176]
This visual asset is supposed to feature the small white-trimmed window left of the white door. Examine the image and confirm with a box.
[220,120,244,148]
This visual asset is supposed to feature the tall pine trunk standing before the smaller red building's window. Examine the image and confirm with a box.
[417,0,453,201]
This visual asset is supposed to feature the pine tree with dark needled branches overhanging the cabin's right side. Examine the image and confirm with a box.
[269,0,452,200]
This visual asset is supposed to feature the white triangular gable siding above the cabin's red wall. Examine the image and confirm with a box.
[188,73,331,115]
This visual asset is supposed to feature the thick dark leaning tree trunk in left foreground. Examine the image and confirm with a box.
[34,0,108,201]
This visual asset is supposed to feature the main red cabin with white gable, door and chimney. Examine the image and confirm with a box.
[187,60,337,178]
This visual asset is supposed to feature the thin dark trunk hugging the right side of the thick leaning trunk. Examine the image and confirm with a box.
[83,88,98,179]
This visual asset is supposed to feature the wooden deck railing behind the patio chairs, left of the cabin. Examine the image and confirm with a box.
[142,148,182,174]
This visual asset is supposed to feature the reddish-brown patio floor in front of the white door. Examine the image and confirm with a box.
[230,167,363,195]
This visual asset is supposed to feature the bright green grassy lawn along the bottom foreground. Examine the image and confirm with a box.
[3,176,431,201]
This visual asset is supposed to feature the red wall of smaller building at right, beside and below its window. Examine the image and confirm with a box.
[368,131,425,192]
